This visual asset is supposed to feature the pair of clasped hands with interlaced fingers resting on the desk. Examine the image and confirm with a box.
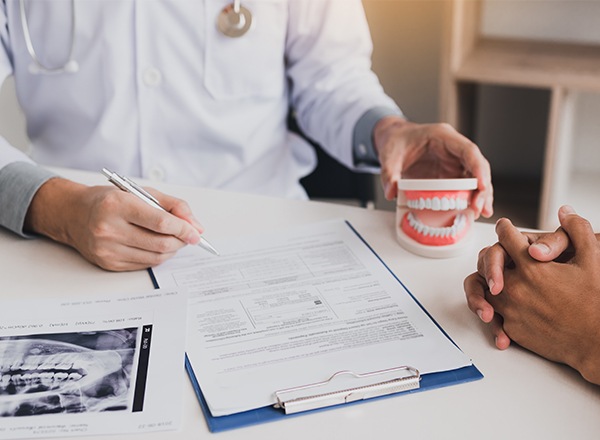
[464,206,600,385]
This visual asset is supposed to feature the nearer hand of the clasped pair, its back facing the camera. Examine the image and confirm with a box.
[465,206,600,384]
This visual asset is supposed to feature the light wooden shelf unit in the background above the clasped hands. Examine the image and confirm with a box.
[440,0,600,229]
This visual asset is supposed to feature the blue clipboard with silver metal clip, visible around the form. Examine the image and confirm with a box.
[148,221,483,432]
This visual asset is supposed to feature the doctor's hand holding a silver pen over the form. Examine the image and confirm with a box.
[24,178,203,271]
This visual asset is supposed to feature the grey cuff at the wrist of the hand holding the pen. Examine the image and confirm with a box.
[0,162,56,237]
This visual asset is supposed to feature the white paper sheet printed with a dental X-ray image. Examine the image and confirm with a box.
[0,289,187,439]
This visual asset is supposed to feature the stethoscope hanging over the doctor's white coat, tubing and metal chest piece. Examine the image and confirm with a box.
[19,0,252,74]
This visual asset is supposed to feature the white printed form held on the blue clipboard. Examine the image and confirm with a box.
[154,220,471,416]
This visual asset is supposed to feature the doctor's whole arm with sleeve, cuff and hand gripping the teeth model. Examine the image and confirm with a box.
[286,0,493,217]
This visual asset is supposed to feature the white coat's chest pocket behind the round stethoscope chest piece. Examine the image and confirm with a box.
[204,0,288,100]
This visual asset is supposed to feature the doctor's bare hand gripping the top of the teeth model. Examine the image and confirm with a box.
[373,116,494,218]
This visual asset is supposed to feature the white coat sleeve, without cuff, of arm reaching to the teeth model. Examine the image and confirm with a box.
[286,0,402,169]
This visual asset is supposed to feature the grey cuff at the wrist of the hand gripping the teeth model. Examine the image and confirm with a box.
[352,107,402,168]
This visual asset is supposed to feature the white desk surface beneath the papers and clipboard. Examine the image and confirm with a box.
[0,170,600,440]
